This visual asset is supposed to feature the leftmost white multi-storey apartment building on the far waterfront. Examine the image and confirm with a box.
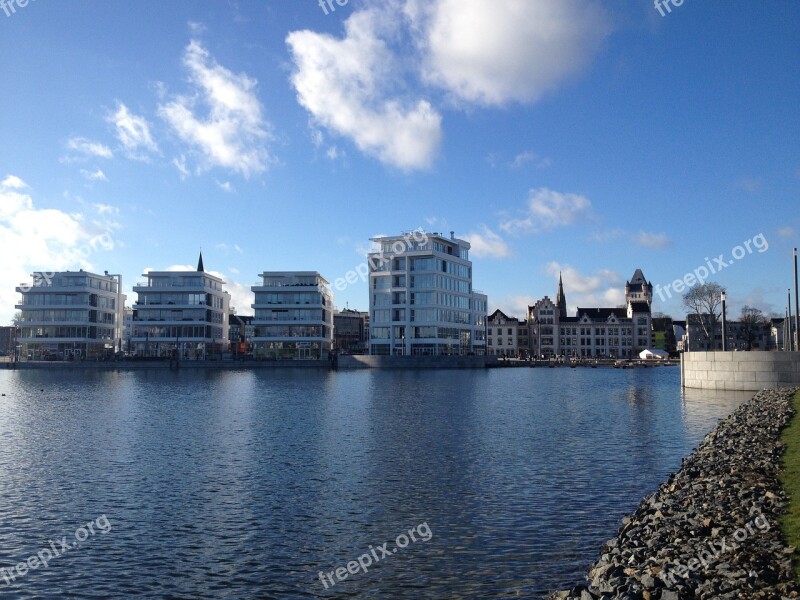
[15,270,125,360]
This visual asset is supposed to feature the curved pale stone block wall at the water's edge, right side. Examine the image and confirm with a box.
[681,351,800,391]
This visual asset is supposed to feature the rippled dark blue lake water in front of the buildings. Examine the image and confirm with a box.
[0,368,743,598]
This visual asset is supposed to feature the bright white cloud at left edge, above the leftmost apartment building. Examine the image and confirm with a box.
[0,176,116,324]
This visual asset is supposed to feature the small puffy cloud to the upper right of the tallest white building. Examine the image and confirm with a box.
[500,188,592,234]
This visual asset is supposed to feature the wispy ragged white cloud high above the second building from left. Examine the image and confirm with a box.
[158,40,272,177]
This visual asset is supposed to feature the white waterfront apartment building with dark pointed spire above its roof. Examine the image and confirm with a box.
[131,254,230,360]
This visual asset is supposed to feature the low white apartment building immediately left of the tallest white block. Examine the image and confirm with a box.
[252,271,333,360]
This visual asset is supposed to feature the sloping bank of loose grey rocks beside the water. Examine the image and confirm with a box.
[551,389,800,600]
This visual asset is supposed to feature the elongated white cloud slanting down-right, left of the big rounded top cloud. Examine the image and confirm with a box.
[286,9,442,171]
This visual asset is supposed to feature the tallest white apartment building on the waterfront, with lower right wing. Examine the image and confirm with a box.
[367,231,487,356]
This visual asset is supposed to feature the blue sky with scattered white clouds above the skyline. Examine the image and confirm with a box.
[0,0,800,323]
